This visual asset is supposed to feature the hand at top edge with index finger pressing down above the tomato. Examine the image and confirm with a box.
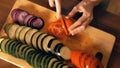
[48,0,62,19]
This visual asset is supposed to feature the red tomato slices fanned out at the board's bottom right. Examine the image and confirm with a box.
[71,51,103,68]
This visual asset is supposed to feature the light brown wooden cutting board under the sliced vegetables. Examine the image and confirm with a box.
[0,0,115,68]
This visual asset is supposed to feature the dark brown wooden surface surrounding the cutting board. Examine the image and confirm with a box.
[0,0,120,68]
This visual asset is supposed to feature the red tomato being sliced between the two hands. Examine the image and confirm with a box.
[47,18,72,39]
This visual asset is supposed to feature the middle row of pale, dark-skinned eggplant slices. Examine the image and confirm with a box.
[5,24,71,60]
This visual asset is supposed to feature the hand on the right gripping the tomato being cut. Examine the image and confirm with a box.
[66,0,94,35]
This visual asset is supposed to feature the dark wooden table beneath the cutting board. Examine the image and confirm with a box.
[0,0,120,68]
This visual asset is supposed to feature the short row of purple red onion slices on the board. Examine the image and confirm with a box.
[11,8,44,29]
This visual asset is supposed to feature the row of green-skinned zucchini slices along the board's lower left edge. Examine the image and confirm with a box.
[0,39,72,68]
